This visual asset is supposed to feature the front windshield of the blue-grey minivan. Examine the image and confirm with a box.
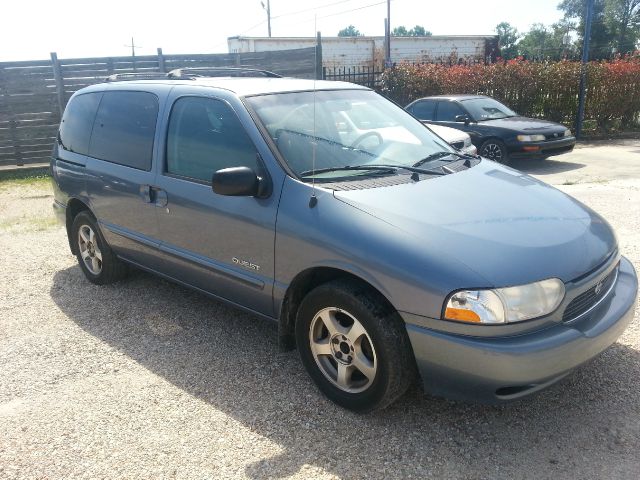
[246,90,450,181]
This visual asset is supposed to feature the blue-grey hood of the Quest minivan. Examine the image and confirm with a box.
[334,159,616,287]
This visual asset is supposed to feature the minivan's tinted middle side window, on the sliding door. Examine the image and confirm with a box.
[89,92,158,170]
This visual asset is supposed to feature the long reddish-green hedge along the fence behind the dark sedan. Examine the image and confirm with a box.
[381,57,640,133]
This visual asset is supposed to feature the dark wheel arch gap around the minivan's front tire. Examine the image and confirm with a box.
[278,266,395,351]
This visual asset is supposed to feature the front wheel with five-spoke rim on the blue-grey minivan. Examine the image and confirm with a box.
[296,280,416,412]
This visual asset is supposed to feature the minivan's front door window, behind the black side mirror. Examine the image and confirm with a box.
[166,97,259,182]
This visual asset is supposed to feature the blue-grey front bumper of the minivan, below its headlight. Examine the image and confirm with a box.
[407,258,638,403]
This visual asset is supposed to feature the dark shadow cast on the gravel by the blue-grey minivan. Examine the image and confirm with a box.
[50,267,640,479]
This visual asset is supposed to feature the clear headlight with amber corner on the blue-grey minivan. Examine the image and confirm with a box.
[444,278,564,324]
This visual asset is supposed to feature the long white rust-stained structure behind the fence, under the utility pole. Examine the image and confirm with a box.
[227,35,499,68]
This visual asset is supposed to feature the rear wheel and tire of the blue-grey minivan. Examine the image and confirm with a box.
[71,211,129,285]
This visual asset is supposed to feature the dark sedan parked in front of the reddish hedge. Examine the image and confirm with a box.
[406,95,576,163]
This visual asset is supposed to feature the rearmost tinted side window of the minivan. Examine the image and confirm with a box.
[58,92,102,155]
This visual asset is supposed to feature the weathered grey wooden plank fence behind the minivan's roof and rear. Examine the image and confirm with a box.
[0,47,322,166]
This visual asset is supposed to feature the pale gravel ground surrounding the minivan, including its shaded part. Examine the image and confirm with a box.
[0,152,640,480]
